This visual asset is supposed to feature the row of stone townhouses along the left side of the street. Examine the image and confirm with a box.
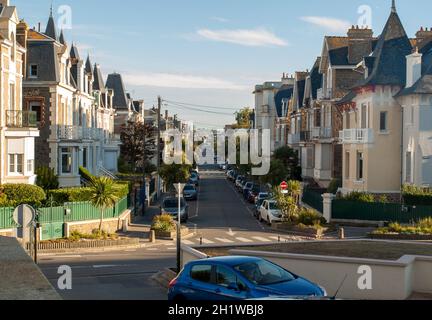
[0,0,144,187]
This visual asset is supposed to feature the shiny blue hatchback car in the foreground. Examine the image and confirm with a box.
[168,256,327,301]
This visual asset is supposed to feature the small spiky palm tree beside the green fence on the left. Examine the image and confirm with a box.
[90,177,119,232]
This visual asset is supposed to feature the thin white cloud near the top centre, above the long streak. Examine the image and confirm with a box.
[197,28,288,47]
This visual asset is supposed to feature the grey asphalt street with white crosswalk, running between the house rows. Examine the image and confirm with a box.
[39,170,285,300]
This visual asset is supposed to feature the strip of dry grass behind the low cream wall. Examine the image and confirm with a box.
[198,241,432,260]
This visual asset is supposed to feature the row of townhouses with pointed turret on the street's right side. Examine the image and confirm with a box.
[255,1,432,195]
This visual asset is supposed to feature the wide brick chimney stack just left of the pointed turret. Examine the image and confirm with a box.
[348,26,373,64]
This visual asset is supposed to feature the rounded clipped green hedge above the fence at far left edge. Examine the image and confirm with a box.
[0,184,46,207]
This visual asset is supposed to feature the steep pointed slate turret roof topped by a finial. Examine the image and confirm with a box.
[358,7,412,86]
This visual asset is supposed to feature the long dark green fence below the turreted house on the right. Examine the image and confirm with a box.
[332,200,432,223]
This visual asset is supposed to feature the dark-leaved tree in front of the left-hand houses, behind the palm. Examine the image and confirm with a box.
[121,121,156,173]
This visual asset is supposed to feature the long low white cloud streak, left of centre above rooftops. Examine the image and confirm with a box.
[124,73,249,90]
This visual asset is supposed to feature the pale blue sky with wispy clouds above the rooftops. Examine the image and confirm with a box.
[10,0,432,128]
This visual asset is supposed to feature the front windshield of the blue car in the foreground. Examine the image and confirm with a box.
[235,260,295,286]
